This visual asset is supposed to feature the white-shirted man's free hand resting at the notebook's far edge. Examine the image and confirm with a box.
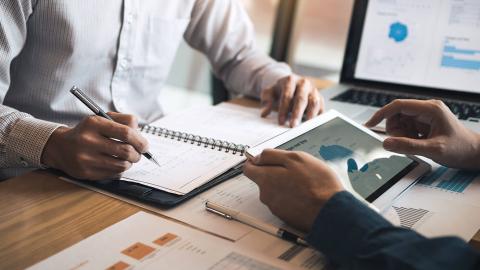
[261,75,324,127]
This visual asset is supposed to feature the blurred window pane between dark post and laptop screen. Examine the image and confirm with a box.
[290,0,353,78]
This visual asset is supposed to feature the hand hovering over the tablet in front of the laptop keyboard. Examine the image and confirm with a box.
[365,100,480,169]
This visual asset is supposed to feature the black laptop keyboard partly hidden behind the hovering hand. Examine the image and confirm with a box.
[332,88,480,122]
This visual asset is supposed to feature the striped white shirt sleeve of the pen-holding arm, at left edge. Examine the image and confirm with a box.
[0,0,61,168]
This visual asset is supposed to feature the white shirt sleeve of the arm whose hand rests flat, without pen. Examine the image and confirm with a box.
[184,0,292,98]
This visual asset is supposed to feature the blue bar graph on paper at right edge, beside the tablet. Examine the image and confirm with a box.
[418,166,480,193]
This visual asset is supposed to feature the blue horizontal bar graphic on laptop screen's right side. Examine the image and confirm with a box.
[441,41,480,71]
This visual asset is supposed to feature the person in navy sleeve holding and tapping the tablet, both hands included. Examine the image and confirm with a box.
[244,100,480,270]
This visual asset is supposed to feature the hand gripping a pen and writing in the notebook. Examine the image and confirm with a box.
[42,113,148,180]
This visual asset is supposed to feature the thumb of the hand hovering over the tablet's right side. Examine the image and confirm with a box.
[383,137,433,157]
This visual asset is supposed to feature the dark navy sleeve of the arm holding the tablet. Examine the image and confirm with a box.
[307,191,480,270]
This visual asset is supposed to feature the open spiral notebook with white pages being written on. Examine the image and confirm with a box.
[122,104,286,195]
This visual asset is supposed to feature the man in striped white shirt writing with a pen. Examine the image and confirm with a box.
[0,0,323,180]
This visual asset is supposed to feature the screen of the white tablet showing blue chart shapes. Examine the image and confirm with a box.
[277,117,418,202]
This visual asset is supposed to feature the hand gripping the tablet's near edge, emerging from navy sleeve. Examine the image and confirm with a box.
[243,150,343,232]
